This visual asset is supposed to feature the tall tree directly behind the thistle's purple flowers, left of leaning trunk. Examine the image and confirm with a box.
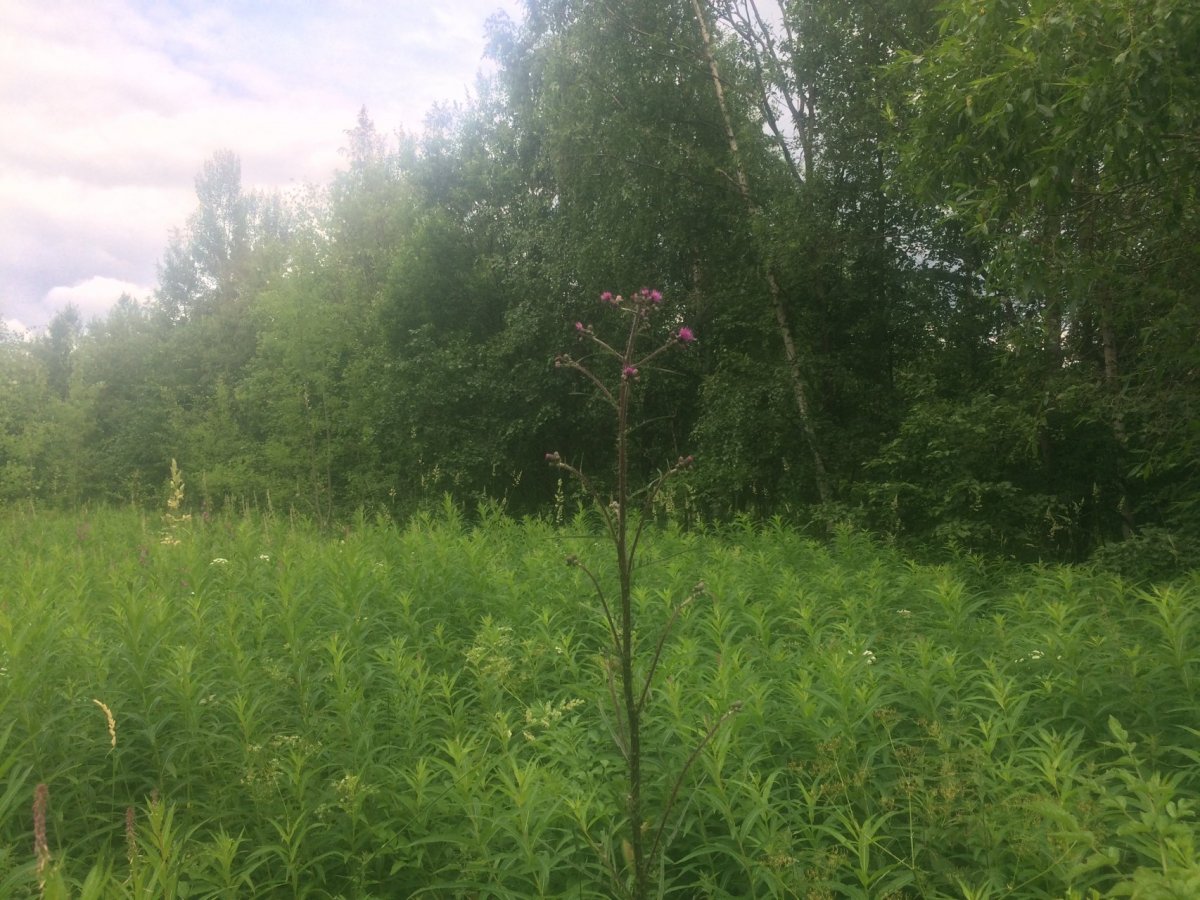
[486,0,769,513]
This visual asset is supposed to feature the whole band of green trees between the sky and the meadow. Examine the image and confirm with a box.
[0,0,1200,559]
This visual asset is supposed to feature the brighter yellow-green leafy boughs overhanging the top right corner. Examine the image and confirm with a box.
[906,0,1200,227]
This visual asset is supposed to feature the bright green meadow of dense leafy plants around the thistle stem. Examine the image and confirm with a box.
[0,509,1200,899]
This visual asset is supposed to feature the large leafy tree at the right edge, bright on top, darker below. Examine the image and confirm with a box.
[895,0,1200,544]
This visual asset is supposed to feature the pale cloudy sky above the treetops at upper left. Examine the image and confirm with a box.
[0,0,521,331]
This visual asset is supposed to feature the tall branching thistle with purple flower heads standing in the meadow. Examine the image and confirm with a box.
[546,288,733,900]
